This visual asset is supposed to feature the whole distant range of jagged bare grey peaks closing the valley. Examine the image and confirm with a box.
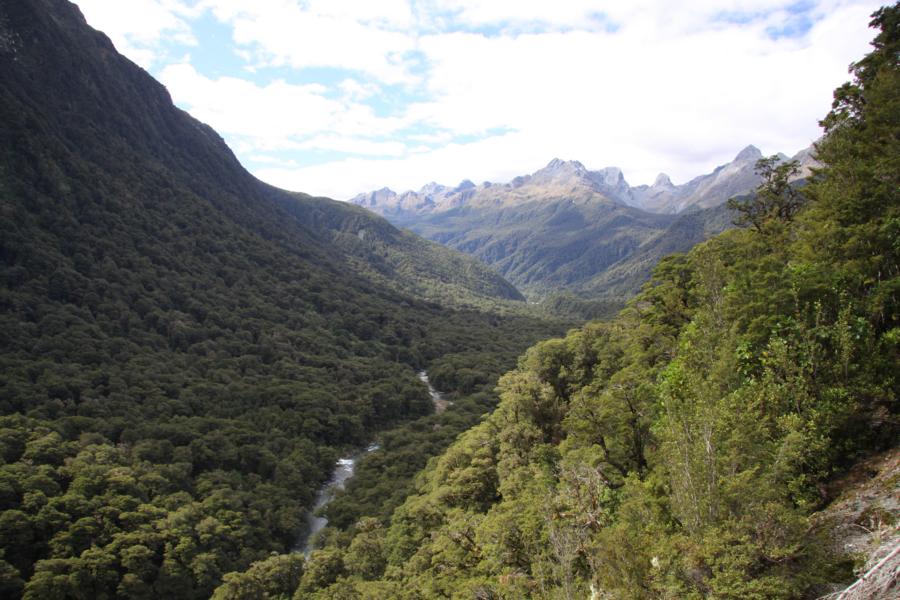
[350,146,814,300]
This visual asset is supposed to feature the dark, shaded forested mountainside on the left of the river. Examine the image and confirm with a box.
[0,0,562,598]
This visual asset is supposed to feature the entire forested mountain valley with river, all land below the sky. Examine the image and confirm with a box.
[0,0,900,600]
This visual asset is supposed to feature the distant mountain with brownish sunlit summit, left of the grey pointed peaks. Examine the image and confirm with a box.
[354,159,674,298]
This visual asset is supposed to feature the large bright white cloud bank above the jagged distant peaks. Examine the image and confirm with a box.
[378,3,872,190]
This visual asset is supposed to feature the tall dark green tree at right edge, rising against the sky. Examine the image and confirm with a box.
[803,3,900,332]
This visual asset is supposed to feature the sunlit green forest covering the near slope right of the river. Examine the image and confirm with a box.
[223,4,900,600]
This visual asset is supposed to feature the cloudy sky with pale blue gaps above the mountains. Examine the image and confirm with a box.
[75,0,879,200]
